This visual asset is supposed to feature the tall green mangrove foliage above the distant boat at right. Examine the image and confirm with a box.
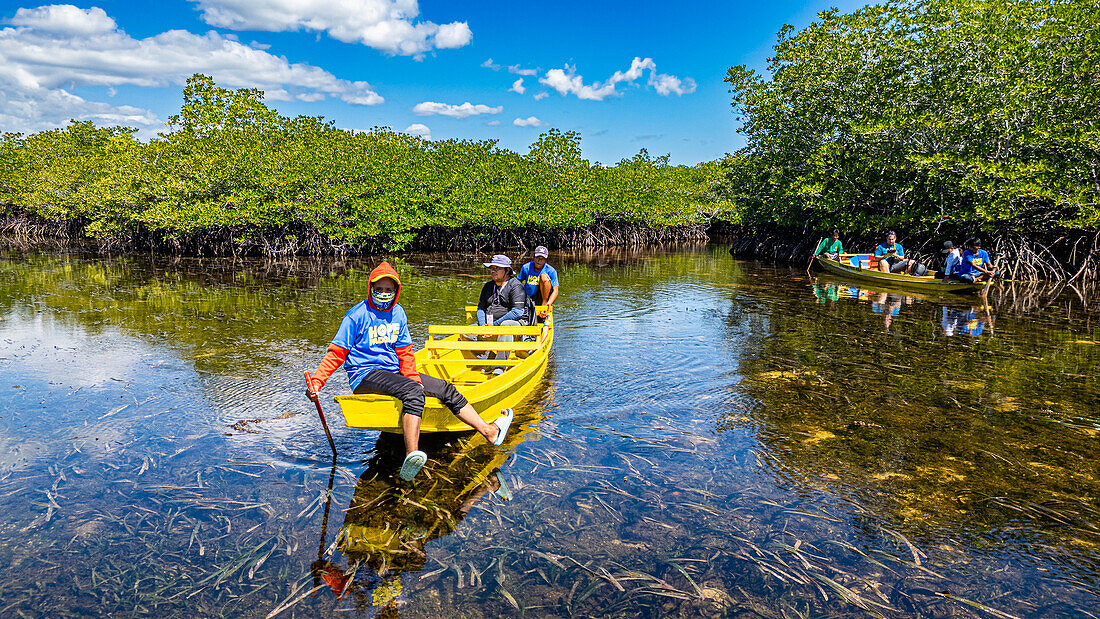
[725,0,1100,232]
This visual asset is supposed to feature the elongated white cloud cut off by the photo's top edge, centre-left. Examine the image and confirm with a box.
[191,0,473,56]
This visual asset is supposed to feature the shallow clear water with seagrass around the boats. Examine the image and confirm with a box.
[0,246,1100,617]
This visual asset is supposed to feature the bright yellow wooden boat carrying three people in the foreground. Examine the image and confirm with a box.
[327,306,553,433]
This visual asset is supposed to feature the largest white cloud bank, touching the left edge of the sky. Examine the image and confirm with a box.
[0,5,384,132]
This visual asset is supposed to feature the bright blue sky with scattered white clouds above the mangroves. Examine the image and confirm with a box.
[0,0,859,164]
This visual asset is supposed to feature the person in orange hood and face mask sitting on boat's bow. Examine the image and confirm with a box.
[306,262,512,482]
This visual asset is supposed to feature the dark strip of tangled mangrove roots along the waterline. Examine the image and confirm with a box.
[0,212,1100,283]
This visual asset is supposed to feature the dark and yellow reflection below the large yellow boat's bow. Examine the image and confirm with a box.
[312,411,537,610]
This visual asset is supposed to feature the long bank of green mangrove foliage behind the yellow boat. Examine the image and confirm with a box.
[0,75,726,250]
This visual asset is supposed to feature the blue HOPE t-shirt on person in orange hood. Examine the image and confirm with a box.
[332,301,413,389]
